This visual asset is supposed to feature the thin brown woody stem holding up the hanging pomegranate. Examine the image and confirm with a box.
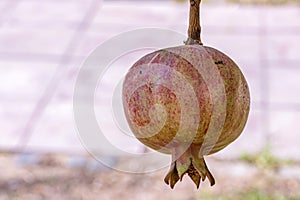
[185,0,202,45]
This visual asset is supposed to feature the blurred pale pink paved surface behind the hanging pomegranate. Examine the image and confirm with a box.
[0,0,300,159]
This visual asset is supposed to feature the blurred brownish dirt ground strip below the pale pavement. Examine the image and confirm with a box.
[0,154,300,200]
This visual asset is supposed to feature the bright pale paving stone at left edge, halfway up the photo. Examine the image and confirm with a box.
[0,61,57,103]
